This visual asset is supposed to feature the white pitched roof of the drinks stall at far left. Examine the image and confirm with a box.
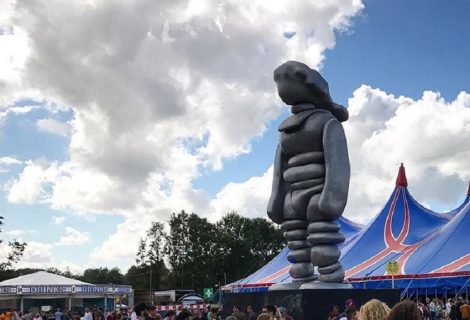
[0,271,90,286]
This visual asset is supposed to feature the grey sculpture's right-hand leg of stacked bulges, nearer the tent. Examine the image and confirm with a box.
[302,194,349,289]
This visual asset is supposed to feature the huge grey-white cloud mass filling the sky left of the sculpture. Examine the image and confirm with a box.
[0,0,363,268]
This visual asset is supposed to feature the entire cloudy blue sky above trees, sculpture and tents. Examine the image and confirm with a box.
[0,0,470,272]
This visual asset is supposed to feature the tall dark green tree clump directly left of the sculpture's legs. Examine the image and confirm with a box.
[129,211,284,292]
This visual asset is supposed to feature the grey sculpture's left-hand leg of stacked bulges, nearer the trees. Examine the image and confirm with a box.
[269,220,316,291]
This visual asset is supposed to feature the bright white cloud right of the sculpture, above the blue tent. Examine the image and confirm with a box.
[345,86,470,222]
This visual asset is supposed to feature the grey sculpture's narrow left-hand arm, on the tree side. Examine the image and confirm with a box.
[268,145,286,224]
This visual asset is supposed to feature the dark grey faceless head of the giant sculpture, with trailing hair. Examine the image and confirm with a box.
[274,61,349,121]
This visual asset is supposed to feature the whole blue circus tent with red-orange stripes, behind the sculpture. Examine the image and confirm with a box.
[226,166,470,294]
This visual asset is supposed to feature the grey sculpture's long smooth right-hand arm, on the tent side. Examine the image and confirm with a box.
[318,119,350,219]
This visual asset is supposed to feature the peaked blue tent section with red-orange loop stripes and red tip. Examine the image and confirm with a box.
[341,166,451,278]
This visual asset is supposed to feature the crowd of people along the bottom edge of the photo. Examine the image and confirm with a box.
[0,297,470,320]
